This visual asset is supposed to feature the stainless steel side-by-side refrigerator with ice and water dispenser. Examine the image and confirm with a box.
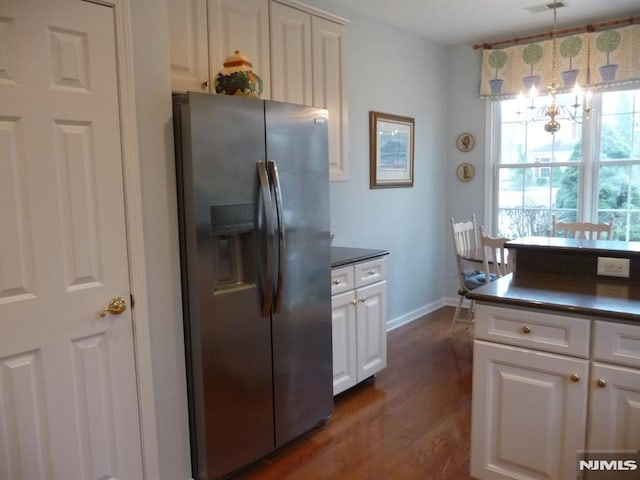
[174,93,333,479]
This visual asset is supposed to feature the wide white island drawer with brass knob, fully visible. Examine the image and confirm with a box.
[475,304,591,358]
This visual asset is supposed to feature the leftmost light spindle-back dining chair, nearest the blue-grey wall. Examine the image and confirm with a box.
[449,214,480,337]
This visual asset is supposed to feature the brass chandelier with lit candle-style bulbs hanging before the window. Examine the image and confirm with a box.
[516,2,592,135]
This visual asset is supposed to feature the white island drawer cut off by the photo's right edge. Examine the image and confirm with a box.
[593,320,640,368]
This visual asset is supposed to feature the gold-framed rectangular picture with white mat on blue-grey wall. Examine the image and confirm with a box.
[369,112,415,188]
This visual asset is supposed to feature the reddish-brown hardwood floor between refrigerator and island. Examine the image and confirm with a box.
[233,307,472,480]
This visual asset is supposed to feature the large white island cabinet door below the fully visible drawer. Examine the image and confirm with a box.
[471,340,588,480]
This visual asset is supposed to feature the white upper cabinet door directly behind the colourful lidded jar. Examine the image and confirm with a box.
[209,0,271,100]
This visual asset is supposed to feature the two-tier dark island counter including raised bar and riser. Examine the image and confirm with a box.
[467,237,640,323]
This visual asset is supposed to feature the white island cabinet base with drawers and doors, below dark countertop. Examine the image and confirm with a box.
[471,303,640,480]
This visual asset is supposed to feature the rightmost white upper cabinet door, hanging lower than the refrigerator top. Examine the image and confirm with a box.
[311,17,348,180]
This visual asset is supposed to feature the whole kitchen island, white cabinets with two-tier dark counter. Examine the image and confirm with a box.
[468,237,640,480]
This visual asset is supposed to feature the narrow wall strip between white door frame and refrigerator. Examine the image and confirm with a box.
[130,0,191,480]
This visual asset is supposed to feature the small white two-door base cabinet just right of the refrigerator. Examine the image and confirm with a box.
[331,258,387,395]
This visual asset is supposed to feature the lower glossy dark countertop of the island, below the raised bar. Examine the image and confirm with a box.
[467,272,640,323]
